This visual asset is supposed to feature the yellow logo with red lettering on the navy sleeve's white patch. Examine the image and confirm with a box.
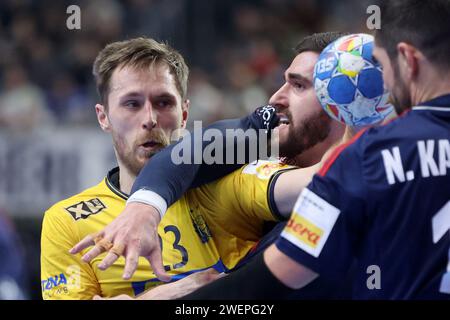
[286,215,323,248]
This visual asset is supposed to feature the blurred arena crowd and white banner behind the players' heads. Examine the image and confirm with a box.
[0,0,374,299]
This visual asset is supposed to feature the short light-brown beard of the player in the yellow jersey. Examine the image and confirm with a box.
[112,129,170,176]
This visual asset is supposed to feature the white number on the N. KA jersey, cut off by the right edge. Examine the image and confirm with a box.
[431,200,450,294]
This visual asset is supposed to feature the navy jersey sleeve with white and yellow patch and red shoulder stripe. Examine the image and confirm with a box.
[276,140,367,282]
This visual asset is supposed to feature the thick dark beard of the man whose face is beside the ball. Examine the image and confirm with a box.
[279,109,333,165]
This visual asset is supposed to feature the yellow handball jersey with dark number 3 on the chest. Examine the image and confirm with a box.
[41,161,291,299]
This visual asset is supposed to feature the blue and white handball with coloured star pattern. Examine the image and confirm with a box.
[314,33,393,127]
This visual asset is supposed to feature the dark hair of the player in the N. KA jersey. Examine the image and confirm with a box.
[375,0,450,68]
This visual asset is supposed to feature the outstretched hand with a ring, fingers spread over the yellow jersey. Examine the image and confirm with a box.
[69,202,170,281]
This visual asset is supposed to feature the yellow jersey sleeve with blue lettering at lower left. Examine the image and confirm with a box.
[41,210,100,300]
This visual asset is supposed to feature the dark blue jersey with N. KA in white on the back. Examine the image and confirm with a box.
[276,95,450,299]
